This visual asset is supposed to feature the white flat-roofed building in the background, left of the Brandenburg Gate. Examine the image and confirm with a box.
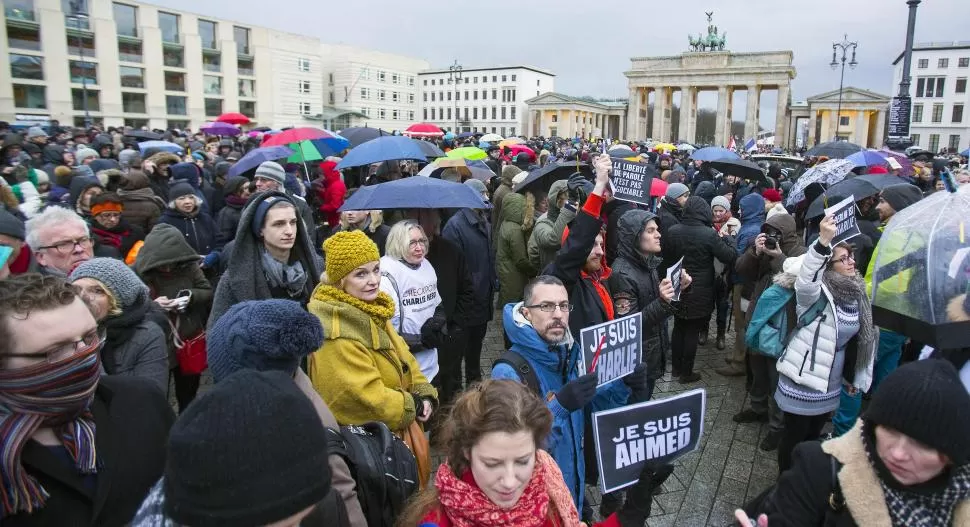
[418,66,556,137]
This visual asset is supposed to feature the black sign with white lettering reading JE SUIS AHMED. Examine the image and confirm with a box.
[593,389,706,494]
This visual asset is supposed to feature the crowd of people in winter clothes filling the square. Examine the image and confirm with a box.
[0,120,970,527]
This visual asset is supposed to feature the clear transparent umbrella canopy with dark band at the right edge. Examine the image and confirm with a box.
[870,186,970,349]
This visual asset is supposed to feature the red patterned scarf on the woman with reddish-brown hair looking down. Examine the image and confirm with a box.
[434,450,579,527]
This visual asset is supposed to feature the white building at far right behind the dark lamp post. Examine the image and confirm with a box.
[893,41,970,152]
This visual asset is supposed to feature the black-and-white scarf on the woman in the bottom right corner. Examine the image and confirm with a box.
[862,422,970,527]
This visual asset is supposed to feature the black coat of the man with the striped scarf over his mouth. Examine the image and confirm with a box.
[3,375,175,527]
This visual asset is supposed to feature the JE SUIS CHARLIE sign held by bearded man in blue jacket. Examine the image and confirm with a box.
[579,311,643,386]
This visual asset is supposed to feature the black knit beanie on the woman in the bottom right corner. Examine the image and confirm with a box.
[863,359,970,465]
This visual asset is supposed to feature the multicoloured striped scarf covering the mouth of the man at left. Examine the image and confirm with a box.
[0,346,101,518]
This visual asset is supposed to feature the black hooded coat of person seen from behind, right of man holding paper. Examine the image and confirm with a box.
[660,196,737,320]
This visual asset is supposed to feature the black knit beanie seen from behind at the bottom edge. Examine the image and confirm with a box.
[163,370,330,527]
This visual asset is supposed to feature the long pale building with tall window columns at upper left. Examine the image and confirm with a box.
[0,0,428,130]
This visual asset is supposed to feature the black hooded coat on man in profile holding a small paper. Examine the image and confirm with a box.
[609,210,674,379]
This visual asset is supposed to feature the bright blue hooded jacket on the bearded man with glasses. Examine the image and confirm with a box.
[491,302,630,510]
